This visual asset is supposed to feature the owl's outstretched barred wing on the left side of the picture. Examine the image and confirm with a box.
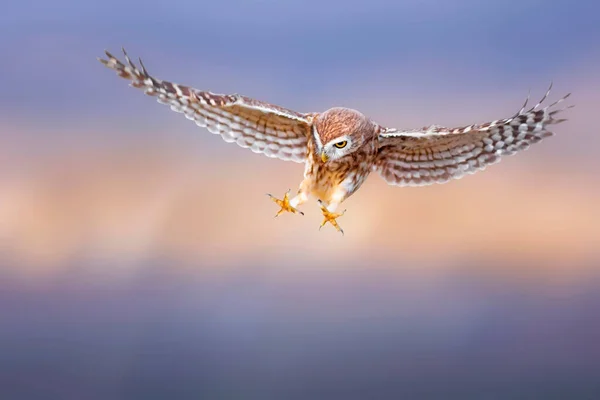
[98,49,310,162]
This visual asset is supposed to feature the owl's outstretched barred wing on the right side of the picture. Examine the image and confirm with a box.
[374,85,572,186]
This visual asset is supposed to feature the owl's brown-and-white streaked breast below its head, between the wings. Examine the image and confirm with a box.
[304,140,376,204]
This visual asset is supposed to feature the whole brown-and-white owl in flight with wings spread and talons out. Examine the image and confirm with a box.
[98,49,570,234]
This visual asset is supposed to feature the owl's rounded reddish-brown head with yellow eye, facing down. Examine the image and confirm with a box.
[313,107,376,162]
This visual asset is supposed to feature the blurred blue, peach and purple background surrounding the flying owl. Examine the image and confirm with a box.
[0,0,600,400]
